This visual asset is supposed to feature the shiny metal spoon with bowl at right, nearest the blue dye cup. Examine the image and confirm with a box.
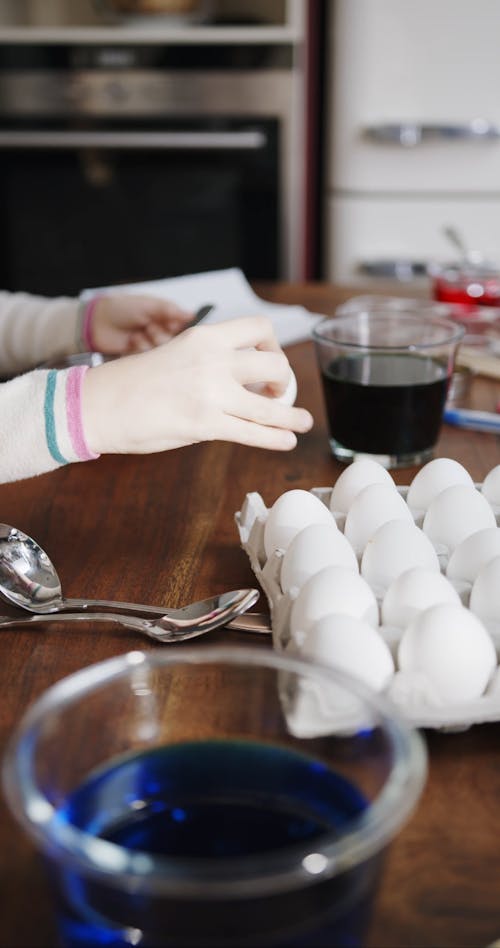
[0,589,259,643]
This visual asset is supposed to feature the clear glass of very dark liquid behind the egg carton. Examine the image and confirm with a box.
[313,308,465,468]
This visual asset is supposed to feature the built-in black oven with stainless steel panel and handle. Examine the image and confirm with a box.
[0,46,293,295]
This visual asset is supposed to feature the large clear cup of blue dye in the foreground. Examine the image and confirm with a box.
[4,646,426,948]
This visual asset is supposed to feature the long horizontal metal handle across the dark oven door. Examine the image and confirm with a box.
[0,129,267,151]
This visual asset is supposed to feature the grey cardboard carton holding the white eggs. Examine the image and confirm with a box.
[235,484,500,736]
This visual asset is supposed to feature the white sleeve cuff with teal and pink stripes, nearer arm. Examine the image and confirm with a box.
[0,366,98,483]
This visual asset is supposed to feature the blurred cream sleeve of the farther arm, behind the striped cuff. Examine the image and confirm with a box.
[0,291,84,378]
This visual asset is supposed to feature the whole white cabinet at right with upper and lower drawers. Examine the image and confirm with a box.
[323,0,500,282]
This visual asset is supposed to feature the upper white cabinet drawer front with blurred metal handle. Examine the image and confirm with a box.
[327,0,500,194]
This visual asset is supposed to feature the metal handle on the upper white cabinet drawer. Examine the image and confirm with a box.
[363,118,500,148]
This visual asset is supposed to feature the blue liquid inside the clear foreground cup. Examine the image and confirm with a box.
[49,741,380,948]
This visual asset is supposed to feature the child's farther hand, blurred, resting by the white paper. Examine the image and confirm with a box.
[87,294,194,355]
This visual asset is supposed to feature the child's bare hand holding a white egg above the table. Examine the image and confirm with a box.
[82,316,313,454]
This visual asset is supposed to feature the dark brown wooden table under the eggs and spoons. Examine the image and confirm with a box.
[0,284,500,948]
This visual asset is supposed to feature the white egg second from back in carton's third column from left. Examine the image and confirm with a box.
[422,484,496,554]
